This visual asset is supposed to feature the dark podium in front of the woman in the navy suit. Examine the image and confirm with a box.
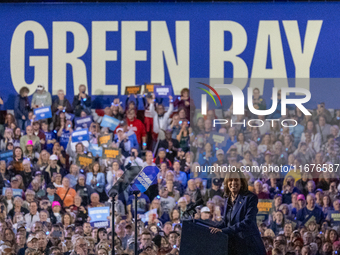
[179,220,228,255]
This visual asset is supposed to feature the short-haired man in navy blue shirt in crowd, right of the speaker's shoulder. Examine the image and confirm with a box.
[296,193,325,226]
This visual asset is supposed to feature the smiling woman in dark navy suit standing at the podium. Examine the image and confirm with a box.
[210,171,266,255]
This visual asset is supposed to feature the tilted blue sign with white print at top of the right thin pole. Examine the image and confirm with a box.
[131,166,159,193]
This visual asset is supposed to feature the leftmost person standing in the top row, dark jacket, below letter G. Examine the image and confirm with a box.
[13,87,30,130]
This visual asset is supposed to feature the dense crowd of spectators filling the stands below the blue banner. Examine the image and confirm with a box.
[0,85,340,255]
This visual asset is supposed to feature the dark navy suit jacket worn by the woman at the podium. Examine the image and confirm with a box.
[218,191,266,255]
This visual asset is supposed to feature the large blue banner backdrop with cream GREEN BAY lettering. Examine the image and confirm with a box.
[0,3,340,109]
